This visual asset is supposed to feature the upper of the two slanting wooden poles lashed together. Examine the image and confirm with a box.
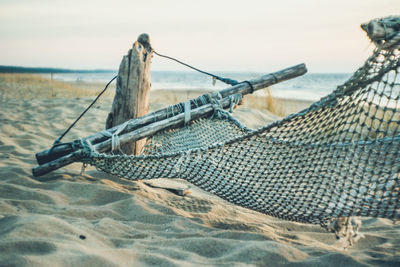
[36,64,307,165]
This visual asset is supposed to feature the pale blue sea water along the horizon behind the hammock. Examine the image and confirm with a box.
[47,71,351,101]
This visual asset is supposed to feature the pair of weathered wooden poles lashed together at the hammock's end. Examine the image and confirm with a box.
[32,64,307,176]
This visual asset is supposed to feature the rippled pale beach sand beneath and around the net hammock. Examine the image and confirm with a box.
[0,81,400,267]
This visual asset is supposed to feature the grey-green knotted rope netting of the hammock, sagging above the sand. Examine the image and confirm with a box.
[81,47,400,225]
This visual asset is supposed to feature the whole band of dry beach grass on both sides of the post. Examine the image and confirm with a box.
[0,73,311,116]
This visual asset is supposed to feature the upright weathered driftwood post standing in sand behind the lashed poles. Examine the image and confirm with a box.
[106,33,152,155]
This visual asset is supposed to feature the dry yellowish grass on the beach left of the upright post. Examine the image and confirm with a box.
[0,73,112,99]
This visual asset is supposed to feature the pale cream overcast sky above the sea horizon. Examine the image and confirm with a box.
[0,0,400,73]
